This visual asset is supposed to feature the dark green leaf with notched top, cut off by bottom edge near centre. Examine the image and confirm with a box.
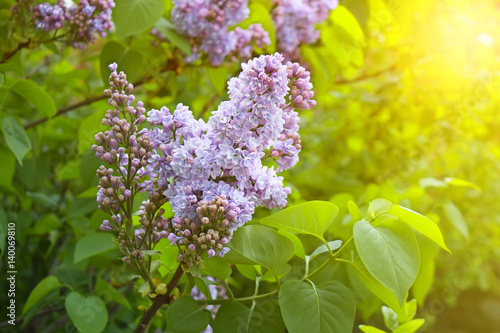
[213,300,285,333]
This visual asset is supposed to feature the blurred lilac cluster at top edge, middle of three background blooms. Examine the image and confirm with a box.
[171,0,271,66]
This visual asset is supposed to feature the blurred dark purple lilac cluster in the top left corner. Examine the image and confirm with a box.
[33,0,115,49]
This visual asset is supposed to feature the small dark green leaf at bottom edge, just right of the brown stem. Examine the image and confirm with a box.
[167,296,208,333]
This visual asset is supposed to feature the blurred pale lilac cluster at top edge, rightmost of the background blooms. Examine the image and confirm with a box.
[272,0,338,60]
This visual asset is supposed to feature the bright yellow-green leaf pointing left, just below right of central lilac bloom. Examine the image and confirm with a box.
[260,201,339,240]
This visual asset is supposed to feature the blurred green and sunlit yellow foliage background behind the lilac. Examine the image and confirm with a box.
[0,0,500,332]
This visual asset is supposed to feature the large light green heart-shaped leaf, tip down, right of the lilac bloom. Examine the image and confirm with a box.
[354,220,420,305]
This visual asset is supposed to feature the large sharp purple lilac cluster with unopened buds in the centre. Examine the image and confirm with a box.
[93,53,315,266]
